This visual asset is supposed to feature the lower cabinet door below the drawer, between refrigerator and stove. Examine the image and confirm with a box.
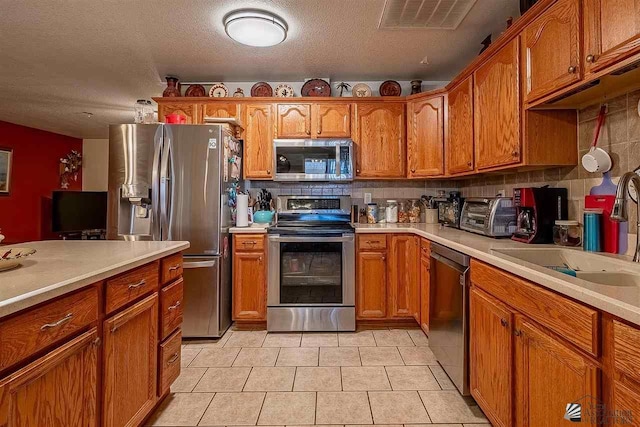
[233,252,267,321]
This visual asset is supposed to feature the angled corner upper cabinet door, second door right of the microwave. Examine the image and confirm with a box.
[407,96,444,178]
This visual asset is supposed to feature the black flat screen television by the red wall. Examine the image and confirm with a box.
[51,191,107,233]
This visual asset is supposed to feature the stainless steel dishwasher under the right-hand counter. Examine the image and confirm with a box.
[429,242,470,396]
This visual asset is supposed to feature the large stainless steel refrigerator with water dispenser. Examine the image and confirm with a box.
[107,124,242,337]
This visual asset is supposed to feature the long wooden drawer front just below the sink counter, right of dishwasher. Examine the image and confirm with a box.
[471,260,600,357]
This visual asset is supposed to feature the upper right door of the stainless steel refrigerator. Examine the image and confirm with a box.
[160,125,223,256]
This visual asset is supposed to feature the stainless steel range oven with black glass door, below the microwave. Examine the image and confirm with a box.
[267,196,356,331]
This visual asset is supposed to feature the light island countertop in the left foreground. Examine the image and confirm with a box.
[0,240,189,317]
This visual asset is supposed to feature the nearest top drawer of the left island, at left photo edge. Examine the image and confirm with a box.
[0,286,98,369]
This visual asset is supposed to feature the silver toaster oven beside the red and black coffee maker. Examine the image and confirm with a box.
[460,197,516,237]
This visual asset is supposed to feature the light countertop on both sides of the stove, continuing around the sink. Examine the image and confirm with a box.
[231,224,640,326]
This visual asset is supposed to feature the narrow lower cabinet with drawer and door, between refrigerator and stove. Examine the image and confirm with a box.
[233,234,267,321]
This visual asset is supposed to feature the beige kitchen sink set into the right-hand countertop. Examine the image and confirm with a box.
[492,247,640,287]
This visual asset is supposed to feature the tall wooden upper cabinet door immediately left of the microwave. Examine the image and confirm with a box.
[244,104,275,179]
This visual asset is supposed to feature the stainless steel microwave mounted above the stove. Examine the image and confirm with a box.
[273,139,353,181]
